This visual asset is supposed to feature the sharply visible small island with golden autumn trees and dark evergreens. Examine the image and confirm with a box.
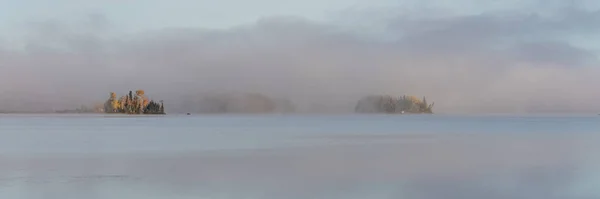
[104,90,165,114]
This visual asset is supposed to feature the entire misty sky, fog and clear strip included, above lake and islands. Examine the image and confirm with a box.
[0,0,600,113]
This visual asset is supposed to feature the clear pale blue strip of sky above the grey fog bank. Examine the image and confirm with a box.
[0,0,400,31]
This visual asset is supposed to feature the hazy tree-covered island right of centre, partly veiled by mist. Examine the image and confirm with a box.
[355,95,433,114]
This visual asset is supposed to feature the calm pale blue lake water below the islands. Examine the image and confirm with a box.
[0,114,600,199]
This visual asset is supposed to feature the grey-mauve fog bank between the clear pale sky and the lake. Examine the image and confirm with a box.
[0,2,600,113]
